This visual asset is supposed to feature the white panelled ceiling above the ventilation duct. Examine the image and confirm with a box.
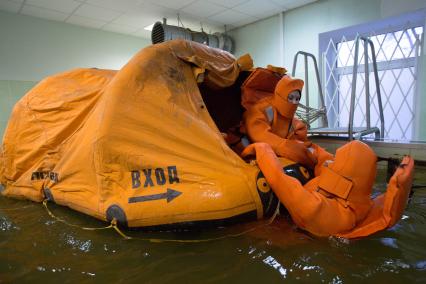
[0,0,317,39]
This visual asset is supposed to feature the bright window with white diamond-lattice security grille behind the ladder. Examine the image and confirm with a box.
[320,10,425,140]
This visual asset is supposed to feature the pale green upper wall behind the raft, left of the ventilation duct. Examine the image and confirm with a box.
[0,11,150,81]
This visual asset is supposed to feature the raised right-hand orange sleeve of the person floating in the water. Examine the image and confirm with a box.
[337,156,414,239]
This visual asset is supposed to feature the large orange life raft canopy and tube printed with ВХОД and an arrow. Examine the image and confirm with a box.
[0,40,312,230]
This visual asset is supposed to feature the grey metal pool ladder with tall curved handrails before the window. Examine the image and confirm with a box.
[292,36,385,140]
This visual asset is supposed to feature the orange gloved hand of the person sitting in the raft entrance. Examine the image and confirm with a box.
[276,139,317,169]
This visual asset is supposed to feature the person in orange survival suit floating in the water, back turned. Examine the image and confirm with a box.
[242,141,414,238]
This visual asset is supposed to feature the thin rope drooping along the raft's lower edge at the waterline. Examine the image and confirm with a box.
[43,199,280,243]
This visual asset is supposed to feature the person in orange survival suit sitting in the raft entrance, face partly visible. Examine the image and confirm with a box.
[243,75,317,169]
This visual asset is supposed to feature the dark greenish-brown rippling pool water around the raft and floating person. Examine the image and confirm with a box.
[0,164,426,283]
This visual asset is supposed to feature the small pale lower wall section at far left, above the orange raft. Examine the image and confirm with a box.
[0,80,37,140]
